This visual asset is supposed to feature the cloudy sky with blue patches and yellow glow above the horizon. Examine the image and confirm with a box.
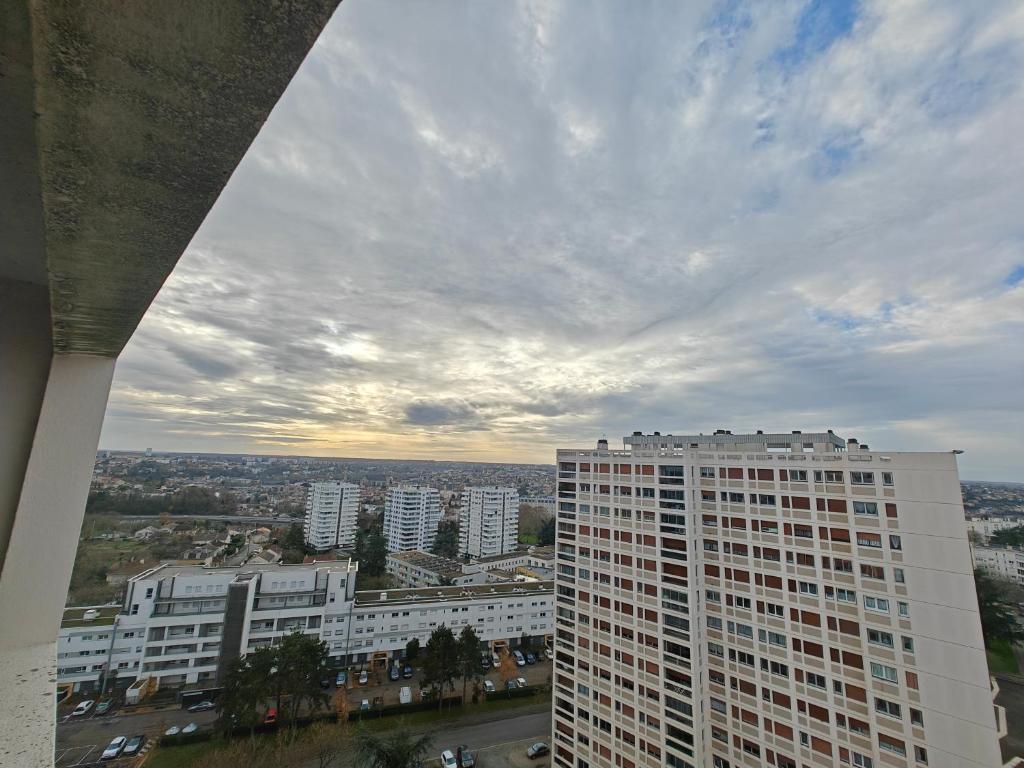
[100,0,1024,480]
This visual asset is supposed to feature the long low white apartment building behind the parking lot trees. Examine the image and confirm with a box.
[57,561,553,689]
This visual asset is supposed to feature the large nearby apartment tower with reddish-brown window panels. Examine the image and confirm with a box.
[552,431,1000,768]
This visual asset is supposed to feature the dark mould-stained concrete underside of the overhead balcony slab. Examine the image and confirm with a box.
[24,0,339,355]
